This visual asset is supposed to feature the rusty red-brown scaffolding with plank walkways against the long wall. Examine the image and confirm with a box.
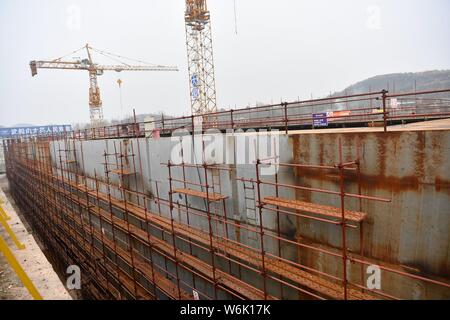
[4,125,450,300]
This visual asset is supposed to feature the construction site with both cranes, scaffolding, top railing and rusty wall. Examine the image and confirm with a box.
[0,0,450,300]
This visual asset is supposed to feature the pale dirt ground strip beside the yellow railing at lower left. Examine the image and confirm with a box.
[0,175,72,300]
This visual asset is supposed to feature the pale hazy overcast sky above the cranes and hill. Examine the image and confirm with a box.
[0,0,450,126]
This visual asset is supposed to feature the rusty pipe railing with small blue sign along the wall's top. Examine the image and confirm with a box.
[64,88,450,140]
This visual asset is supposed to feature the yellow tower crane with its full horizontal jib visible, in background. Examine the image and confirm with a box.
[30,44,178,127]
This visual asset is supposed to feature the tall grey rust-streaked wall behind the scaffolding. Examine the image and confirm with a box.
[52,131,450,299]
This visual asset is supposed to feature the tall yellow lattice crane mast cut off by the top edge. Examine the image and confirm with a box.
[185,0,217,115]
